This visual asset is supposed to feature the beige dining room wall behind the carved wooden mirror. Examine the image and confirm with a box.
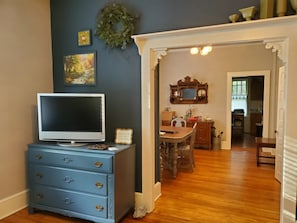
[160,44,275,139]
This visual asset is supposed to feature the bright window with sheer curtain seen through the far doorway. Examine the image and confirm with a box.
[232,78,248,116]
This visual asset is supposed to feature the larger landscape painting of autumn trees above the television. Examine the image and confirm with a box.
[64,52,96,85]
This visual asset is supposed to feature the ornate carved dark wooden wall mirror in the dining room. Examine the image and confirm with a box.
[170,76,208,104]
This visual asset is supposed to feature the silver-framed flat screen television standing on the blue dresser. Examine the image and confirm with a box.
[37,93,105,146]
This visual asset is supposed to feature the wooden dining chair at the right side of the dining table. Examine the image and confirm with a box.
[177,123,197,171]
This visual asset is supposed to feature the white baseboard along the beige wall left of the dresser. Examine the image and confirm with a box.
[0,190,28,220]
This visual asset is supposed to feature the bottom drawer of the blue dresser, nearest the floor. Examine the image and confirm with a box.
[30,186,108,218]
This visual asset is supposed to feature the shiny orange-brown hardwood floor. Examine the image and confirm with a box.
[0,135,280,223]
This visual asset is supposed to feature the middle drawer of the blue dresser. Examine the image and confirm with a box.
[29,164,108,196]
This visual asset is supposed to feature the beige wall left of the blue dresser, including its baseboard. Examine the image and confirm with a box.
[0,0,53,219]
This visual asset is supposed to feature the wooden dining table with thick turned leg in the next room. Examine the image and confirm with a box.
[160,125,193,178]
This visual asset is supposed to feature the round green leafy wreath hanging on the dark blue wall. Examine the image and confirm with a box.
[95,3,136,49]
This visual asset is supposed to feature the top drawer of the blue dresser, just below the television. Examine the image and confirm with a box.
[29,148,113,173]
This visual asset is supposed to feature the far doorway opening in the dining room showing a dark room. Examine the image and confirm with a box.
[231,73,264,148]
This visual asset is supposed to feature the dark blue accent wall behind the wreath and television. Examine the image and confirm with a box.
[51,0,286,192]
